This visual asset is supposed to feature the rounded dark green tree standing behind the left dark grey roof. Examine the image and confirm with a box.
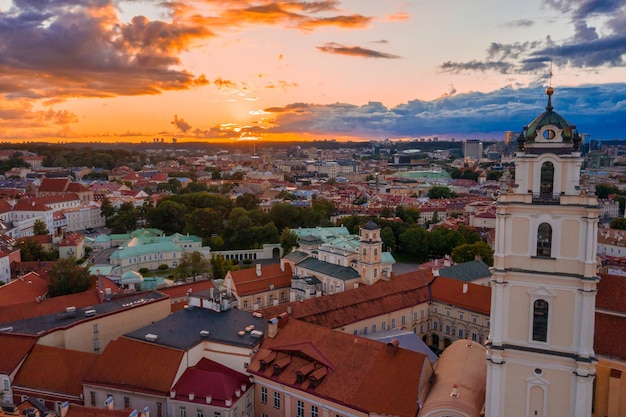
[48,259,93,297]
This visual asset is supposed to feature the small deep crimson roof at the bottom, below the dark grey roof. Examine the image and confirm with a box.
[173,358,251,408]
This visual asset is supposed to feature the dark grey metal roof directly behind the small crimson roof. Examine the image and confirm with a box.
[125,307,267,350]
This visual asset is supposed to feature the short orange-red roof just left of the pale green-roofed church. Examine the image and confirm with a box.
[228,263,293,297]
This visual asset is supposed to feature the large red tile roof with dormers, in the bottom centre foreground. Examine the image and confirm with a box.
[248,318,431,417]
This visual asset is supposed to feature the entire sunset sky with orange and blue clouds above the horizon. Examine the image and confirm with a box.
[0,0,626,142]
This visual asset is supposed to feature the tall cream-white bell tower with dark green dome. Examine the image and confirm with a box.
[485,87,599,417]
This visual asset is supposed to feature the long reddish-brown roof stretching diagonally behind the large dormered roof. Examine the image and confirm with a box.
[259,270,433,329]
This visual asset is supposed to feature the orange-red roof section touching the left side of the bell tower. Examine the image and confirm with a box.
[431,277,491,315]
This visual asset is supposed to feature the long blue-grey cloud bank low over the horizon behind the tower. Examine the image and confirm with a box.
[265,84,626,139]
